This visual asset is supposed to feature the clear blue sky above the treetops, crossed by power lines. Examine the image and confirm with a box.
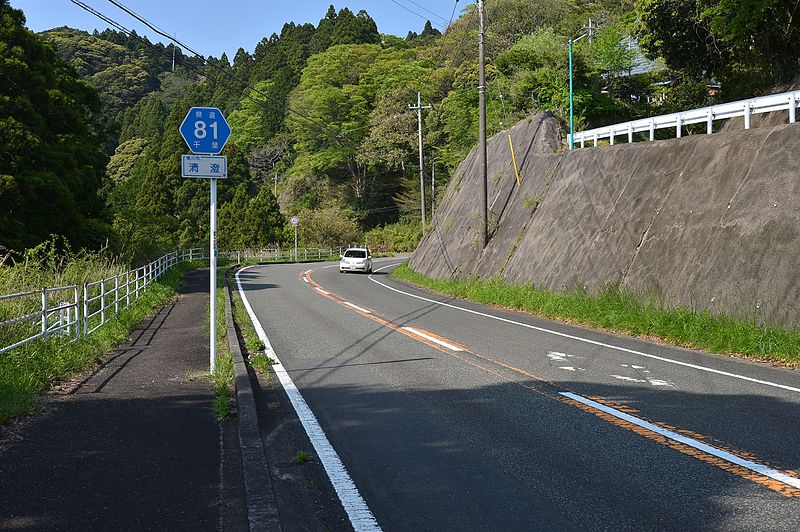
[10,0,466,58]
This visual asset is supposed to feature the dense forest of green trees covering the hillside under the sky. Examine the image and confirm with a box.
[0,0,800,262]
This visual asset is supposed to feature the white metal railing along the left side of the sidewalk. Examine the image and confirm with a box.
[0,249,206,354]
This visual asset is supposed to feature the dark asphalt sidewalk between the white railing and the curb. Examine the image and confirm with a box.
[0,270,248,531]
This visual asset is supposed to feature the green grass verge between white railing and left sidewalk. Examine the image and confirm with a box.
[0,263,196,424]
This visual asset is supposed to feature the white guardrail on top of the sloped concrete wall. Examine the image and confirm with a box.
[572,91,800,148]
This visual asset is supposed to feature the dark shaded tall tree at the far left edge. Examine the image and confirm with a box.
[0,1,110,251]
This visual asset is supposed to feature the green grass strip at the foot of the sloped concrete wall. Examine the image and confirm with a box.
[392,264,800,366]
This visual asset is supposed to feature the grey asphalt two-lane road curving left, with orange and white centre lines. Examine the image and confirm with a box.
[240,259,800,531]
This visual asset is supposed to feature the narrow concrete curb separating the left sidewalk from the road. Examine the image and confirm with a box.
[224,277,282,532]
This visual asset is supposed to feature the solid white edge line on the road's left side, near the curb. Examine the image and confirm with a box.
[236,266,381,532]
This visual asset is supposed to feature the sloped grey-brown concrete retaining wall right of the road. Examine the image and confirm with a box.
[411,114,800,327]
